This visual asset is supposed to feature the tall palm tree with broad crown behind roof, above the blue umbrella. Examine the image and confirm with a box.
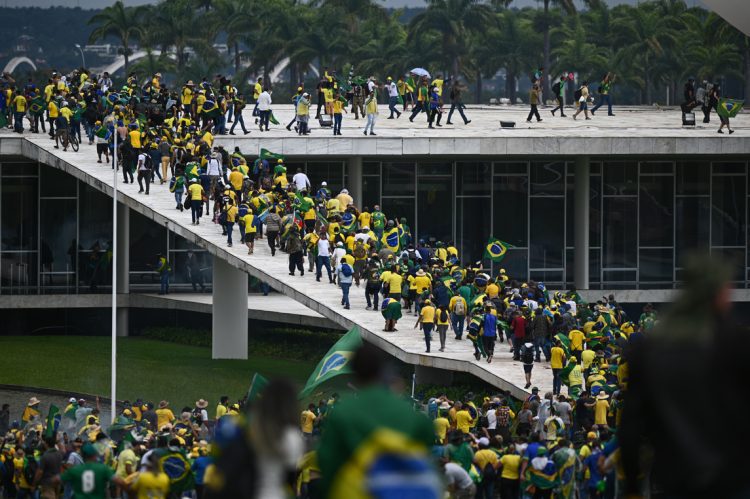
[409,0,495,77]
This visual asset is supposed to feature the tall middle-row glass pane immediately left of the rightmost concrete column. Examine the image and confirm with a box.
[529,198,565,269]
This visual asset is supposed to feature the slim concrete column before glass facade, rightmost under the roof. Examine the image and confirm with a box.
[573,156,591,289]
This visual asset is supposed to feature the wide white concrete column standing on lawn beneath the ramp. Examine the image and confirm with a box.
[211,256,247,359]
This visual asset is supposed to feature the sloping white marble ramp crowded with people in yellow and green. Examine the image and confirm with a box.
[0,132,564,397]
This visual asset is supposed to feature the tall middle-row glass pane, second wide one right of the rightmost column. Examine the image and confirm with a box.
[639,175,674,246]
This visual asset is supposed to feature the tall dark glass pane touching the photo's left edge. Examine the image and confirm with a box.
[0,177,38,250]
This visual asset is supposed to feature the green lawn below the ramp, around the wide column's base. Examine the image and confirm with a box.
[0,336,315,410]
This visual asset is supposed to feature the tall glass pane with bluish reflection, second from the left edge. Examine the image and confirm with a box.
[39,199,78,276]
